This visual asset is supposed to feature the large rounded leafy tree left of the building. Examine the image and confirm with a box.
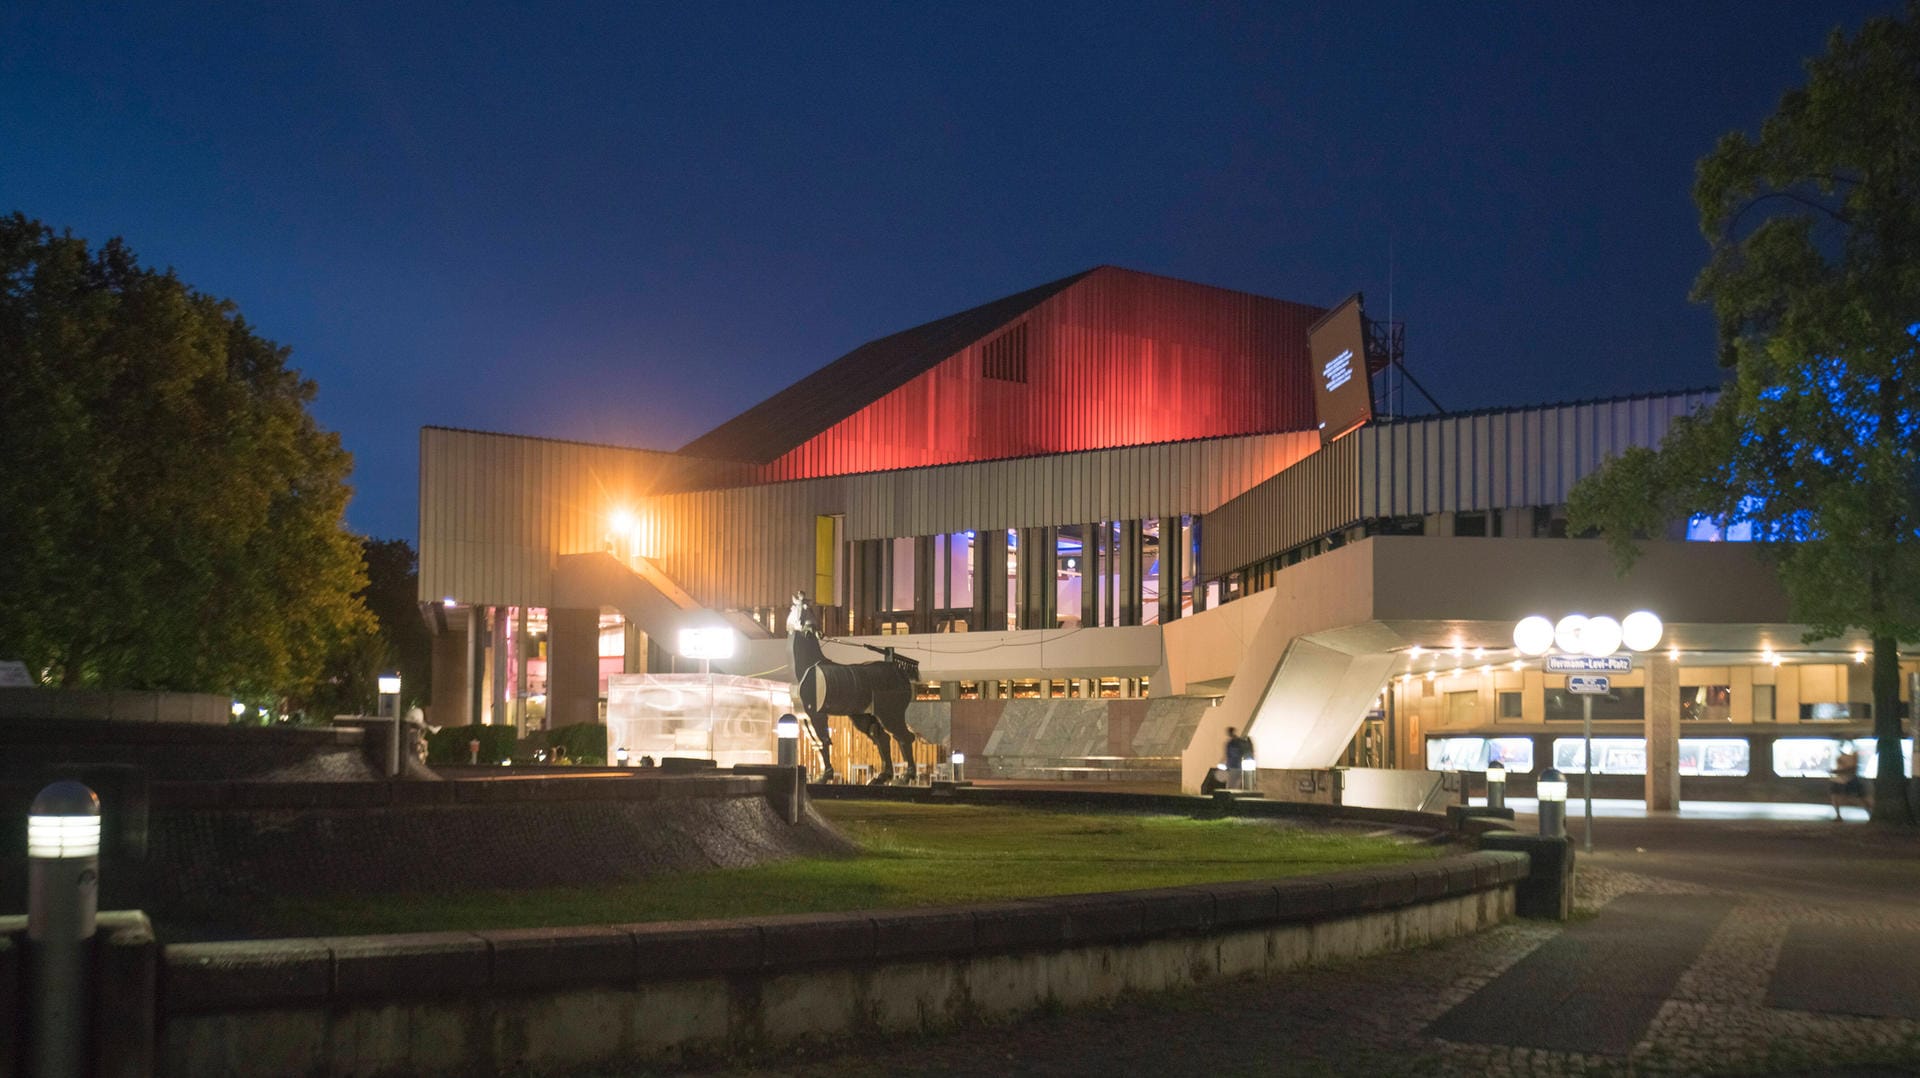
[0,213,371,699]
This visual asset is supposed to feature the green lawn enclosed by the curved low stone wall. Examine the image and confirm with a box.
[259,801,1440,936]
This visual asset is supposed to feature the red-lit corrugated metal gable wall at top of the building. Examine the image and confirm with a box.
[760,267,1321,480]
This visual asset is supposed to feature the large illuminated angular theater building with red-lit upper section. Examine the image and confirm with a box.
[420,267,1905,805]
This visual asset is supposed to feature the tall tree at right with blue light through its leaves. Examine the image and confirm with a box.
[1569,0,1920,822]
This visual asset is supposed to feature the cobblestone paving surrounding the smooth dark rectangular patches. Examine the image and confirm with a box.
[648,821,1920,1078]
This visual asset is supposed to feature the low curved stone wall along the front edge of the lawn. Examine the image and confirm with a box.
[149,851,1528,1076]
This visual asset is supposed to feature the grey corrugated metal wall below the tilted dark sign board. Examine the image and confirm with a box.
[1200,392,1715,578]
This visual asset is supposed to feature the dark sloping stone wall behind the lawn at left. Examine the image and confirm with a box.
[0,769,852,922]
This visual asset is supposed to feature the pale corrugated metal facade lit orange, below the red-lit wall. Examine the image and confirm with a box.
[420,429,1319,609]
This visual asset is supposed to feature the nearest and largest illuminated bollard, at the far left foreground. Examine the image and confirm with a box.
[27,782,100,1074]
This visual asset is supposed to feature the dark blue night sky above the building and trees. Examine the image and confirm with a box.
[0,0,1897,540]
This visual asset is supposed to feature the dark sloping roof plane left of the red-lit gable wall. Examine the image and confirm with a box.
[680,269,1092,465]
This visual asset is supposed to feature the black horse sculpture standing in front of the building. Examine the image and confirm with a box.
[787,592,920,786]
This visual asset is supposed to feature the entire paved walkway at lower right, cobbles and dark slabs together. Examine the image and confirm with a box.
[641,817,1920,1078]
